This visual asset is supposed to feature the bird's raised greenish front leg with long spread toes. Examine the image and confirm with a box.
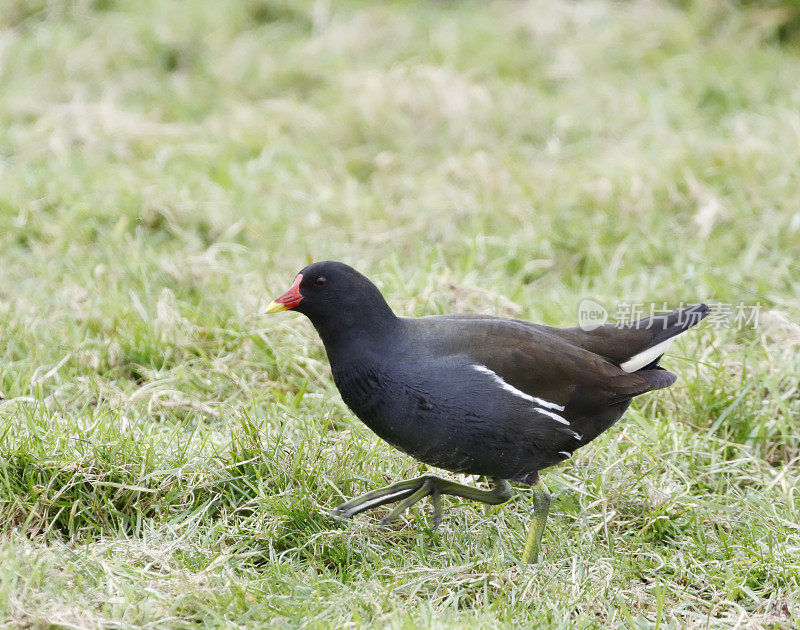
[333,475,511,529]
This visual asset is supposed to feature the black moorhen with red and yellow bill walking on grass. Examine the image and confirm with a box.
[266,261,708,562]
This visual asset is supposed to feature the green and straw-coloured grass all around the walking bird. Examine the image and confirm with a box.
[0,0,800,628]
